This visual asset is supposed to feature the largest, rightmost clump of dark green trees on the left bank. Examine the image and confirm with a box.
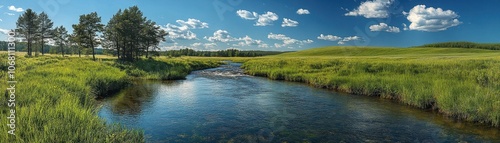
[103,6,168,61]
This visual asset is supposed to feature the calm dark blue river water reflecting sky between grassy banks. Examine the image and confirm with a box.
[98,63,500,142]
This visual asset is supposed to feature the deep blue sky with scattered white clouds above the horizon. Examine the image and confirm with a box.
[0,0,500,51]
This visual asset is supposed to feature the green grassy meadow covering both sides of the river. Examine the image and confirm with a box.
[0,47,500,142]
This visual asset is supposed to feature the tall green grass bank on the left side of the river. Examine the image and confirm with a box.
[0,54,219,143]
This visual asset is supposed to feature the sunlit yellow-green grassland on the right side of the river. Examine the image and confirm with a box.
[243,47,500,127]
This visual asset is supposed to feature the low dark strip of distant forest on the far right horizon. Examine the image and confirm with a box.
[418,42,500,50]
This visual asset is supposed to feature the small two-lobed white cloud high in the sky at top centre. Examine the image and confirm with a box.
[236,10,279,26]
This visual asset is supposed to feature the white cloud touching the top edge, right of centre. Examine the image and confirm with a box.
[345,0,394,18]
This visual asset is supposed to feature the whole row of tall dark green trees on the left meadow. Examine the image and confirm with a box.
[16,6,168,61]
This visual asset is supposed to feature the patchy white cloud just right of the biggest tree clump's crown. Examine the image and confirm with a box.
[160,18,208,43]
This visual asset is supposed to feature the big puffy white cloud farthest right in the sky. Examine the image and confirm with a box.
[403,5,462,32]
